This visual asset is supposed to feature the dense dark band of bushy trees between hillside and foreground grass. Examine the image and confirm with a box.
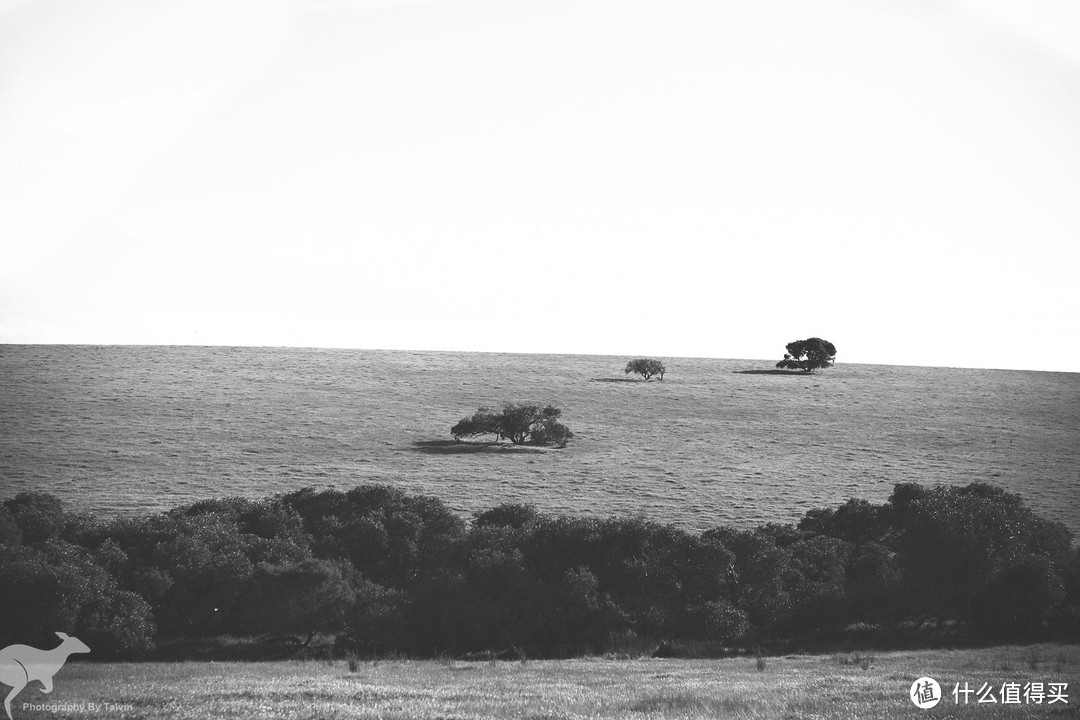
[0,484,1080,658]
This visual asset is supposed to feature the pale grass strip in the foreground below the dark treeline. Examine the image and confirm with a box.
[13,646,1080,720]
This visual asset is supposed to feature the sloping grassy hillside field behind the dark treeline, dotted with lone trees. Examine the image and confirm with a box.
[0,343,1080,532]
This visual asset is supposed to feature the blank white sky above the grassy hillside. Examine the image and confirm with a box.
[0,0,1080,371]
